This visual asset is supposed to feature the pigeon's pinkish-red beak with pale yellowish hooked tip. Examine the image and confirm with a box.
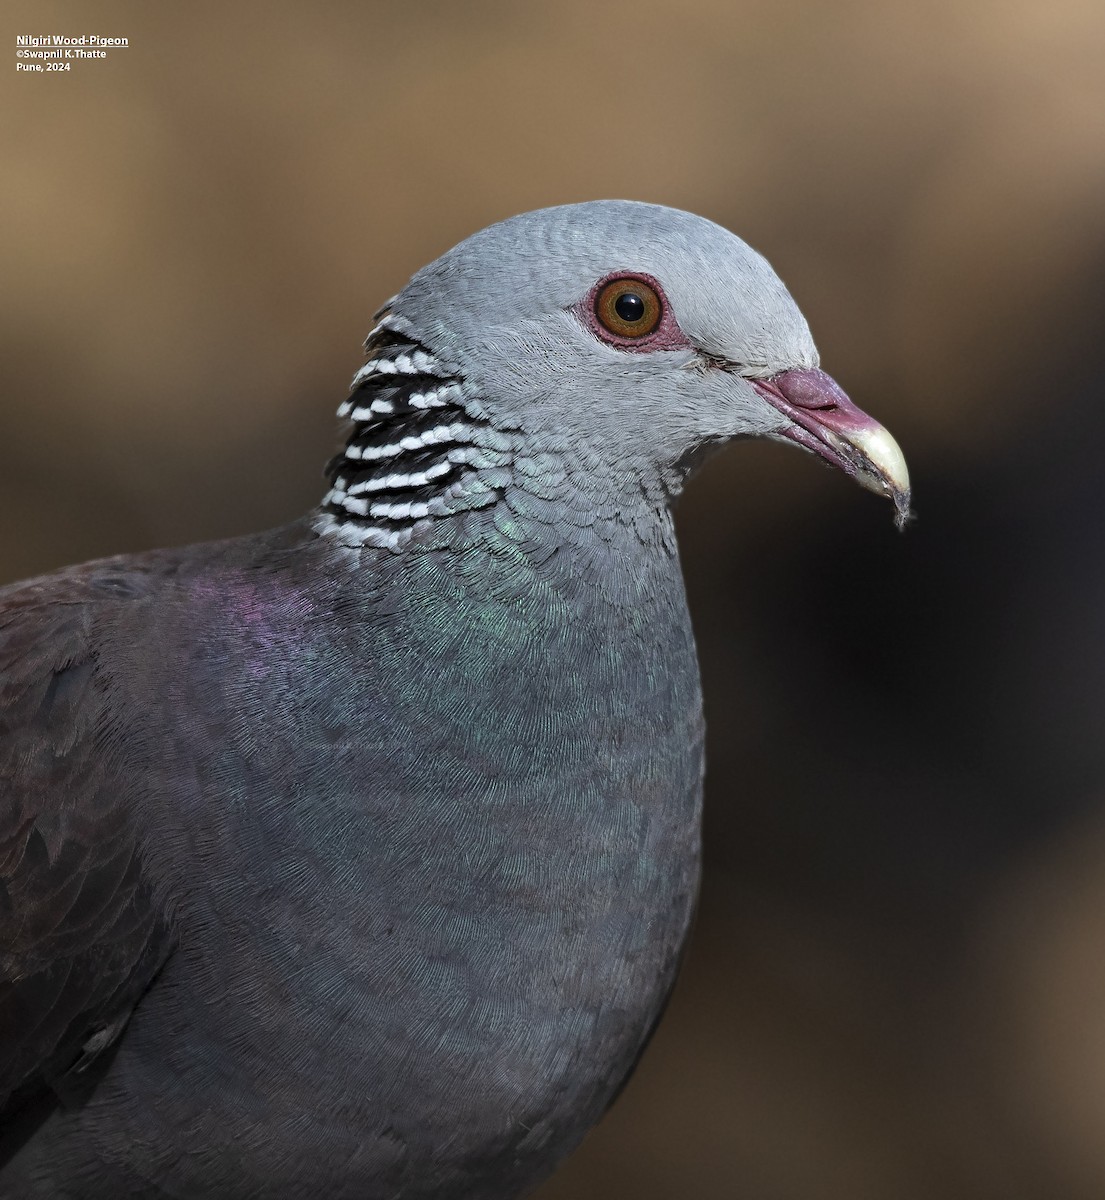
[749,368,909,529]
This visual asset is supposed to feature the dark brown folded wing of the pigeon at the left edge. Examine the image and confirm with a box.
[0,569,168,1108]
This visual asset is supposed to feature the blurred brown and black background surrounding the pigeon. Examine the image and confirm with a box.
[0,0,1105,1200]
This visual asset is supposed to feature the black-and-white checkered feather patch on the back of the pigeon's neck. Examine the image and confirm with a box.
[317,307,514,551]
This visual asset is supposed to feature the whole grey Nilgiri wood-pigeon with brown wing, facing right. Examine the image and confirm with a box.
[0,202,908,1200]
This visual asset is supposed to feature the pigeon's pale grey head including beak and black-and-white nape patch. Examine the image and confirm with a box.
[324,200,909,548]
